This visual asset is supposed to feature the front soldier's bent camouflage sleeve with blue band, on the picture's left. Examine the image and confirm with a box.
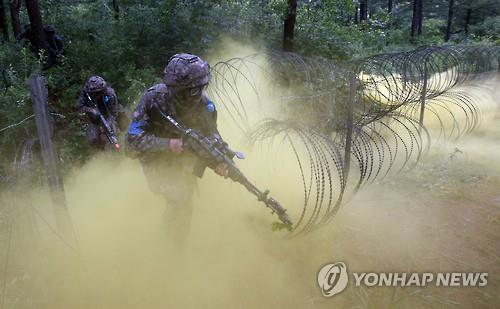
[126,91,170,156]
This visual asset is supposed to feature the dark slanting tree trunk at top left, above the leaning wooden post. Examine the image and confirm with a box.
[26,0,53,67]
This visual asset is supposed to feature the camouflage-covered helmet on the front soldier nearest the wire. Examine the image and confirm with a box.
[163,54,211,88]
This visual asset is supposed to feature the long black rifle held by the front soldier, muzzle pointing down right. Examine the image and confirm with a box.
[158,108,292,230]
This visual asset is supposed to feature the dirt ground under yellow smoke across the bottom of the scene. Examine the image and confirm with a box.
[0,119,500,308]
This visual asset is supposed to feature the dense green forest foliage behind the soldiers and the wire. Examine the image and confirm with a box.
[0,0,500,176]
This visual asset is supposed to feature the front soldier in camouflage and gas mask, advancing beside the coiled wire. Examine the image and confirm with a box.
[126,54,227,237]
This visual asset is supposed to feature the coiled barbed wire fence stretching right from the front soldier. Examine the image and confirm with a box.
[209,45,500,234]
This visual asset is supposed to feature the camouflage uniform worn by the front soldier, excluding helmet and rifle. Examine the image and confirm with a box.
[127,83,219,204]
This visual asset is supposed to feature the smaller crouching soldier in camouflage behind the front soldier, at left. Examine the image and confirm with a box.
[80,75,124,150]
